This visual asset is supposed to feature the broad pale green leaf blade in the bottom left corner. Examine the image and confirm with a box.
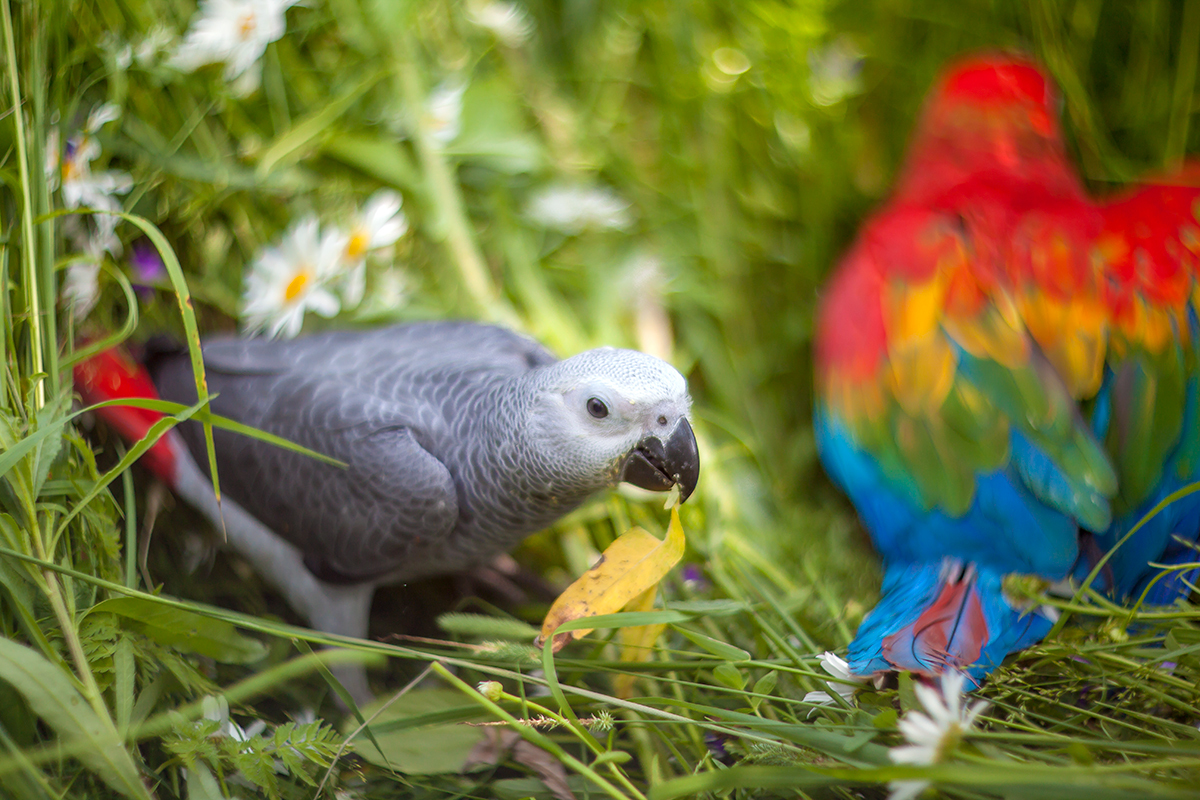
[0,638,150,800]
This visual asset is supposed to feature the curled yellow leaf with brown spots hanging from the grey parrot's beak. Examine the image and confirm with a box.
[538,509,685,652]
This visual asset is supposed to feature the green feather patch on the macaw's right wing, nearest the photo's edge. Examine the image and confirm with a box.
[1108,347,1194,511]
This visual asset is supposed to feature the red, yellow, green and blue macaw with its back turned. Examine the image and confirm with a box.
[815,55,1196,679]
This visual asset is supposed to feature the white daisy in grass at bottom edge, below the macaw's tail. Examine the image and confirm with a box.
[888,672,989,800]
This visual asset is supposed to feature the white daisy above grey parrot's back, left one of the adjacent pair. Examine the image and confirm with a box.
[241,216,346,338]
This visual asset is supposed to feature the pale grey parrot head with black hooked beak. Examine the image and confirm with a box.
[529,348,700,500]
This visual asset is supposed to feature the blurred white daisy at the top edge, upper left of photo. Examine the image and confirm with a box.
[170,0,296,85]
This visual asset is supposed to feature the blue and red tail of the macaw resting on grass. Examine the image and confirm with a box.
[850,559,1054,685]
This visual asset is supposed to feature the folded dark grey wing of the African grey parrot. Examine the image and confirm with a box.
[155,323,554,581]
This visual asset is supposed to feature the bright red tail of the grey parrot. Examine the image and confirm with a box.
[74,348,182,486]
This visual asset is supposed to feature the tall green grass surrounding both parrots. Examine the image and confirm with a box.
[0,0,1200,800]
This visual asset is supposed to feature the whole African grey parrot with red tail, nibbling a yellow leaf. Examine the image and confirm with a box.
[76,321,700,698]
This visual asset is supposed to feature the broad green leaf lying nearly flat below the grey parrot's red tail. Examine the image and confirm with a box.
[90,597,266,664]
